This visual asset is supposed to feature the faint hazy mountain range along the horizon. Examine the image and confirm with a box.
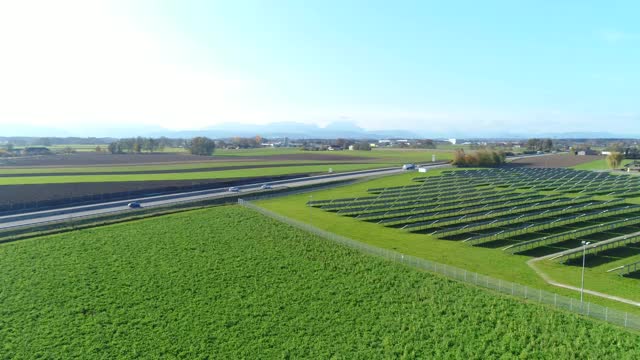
[0,122,640,140]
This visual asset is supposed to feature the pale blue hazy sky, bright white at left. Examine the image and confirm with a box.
[0,0,640,135]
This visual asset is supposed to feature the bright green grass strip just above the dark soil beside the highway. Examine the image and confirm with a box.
[0,163,395,185]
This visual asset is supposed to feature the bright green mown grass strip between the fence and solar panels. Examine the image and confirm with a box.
[259,170,640,314]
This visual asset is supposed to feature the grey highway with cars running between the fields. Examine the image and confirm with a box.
[0,163,449,230]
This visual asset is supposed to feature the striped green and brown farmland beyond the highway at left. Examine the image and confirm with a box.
[0,148,451,206]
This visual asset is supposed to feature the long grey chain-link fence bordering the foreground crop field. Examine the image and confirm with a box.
[238,199,640,330]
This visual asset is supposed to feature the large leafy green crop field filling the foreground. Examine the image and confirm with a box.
[0,207,640,359]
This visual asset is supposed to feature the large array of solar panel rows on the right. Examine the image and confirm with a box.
[308,168,640,268]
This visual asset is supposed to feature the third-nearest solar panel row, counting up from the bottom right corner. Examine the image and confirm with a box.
[503,216,640,254]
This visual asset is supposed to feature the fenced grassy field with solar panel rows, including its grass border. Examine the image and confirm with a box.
[259,168,640,313]
